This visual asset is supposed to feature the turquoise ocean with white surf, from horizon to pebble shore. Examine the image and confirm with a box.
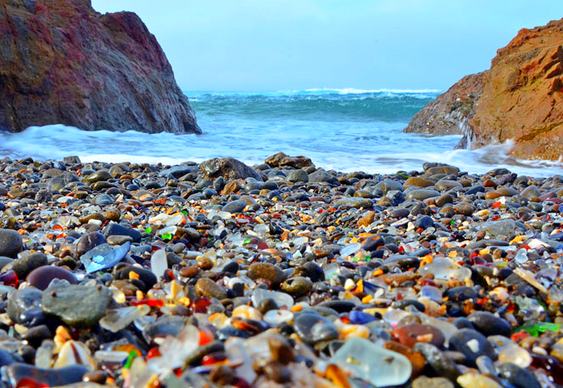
[0,89,563,177]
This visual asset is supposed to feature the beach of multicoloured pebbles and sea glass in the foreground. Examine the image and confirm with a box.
[0,153,563,388]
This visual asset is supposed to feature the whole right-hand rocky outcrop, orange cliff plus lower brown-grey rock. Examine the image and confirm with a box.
[407,19,563,160]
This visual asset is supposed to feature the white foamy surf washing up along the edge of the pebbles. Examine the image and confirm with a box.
[0,124,563,177]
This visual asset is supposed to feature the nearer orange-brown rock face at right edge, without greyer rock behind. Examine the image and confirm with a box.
[469,19,563,159]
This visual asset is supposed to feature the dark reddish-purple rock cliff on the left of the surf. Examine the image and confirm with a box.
[0,0,200,133]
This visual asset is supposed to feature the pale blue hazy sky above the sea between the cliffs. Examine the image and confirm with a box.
[93,0,563,91]
